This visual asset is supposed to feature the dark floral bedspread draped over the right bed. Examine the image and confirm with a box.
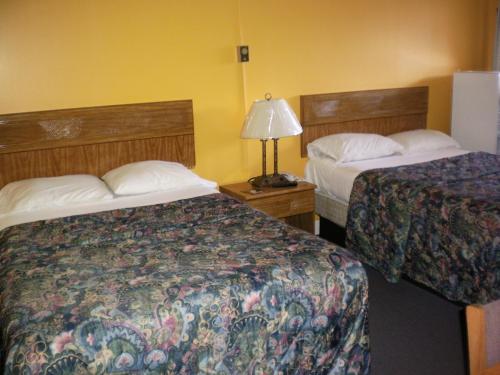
[346,152,500,303]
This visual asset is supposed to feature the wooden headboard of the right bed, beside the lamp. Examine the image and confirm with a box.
[300,87,429,157]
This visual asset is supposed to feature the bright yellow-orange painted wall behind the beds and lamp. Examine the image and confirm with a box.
[0,0,491,183]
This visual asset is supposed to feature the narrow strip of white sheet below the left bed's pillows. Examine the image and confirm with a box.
[0,183,219,230]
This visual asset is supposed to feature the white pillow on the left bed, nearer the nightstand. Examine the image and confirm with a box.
[102,160,217,195]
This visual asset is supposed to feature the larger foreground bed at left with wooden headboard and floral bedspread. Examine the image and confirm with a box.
[0,101,369,374]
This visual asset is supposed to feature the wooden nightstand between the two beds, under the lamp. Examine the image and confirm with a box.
[220,182,316,233]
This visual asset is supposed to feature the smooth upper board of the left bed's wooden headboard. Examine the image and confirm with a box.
[0,100,193,153]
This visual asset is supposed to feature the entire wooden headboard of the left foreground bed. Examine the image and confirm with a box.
[0,100,195,187]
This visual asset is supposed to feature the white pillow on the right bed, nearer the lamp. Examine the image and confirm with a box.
[307,133,403,163]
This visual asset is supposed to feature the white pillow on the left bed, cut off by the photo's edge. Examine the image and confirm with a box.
[0,175,114,214]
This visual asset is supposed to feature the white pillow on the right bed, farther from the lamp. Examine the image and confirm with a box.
[389,129,460,154]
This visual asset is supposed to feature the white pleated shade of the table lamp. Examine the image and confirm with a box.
[241,99,302,139]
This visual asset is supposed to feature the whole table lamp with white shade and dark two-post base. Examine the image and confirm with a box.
[241,93,302,188]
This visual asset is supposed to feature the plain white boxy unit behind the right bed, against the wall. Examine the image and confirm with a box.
[451,72,500,154]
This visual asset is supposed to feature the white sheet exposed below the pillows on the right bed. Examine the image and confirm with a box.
[305,148,470,204]
